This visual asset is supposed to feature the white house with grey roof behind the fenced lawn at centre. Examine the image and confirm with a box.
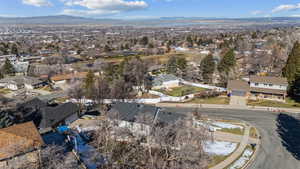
[152,74,180,89]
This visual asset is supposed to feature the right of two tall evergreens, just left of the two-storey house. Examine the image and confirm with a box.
[218,49,236,74]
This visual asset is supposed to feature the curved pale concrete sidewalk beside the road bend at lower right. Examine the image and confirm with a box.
[210,126,250,169]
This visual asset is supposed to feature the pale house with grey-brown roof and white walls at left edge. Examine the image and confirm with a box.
[0,76,46,90]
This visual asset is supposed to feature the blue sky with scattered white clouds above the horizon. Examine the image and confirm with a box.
[0,0,300,19]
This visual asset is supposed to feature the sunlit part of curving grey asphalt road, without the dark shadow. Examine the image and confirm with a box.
[166,107,300,169]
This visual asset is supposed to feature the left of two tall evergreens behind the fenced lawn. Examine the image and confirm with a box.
[200,55,216,83]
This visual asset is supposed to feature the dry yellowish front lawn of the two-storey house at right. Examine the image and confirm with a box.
[248,98,300,108]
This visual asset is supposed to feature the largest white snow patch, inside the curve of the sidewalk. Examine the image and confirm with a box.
[204,141,238,156]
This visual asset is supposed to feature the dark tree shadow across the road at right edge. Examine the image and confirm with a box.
[277,114,300,160]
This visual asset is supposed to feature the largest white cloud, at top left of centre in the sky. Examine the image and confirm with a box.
[61,0,148,15]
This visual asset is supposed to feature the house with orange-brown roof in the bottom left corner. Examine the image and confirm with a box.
[0,122,44,168]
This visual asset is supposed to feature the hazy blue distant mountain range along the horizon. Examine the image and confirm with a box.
[0,15,300,26]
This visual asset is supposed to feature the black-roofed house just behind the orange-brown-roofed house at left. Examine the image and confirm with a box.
[17,98,79,133]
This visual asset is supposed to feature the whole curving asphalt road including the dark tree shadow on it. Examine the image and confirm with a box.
[165,107,300,169]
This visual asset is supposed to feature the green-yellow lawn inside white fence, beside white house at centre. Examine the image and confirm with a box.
[159,85,206,97]
